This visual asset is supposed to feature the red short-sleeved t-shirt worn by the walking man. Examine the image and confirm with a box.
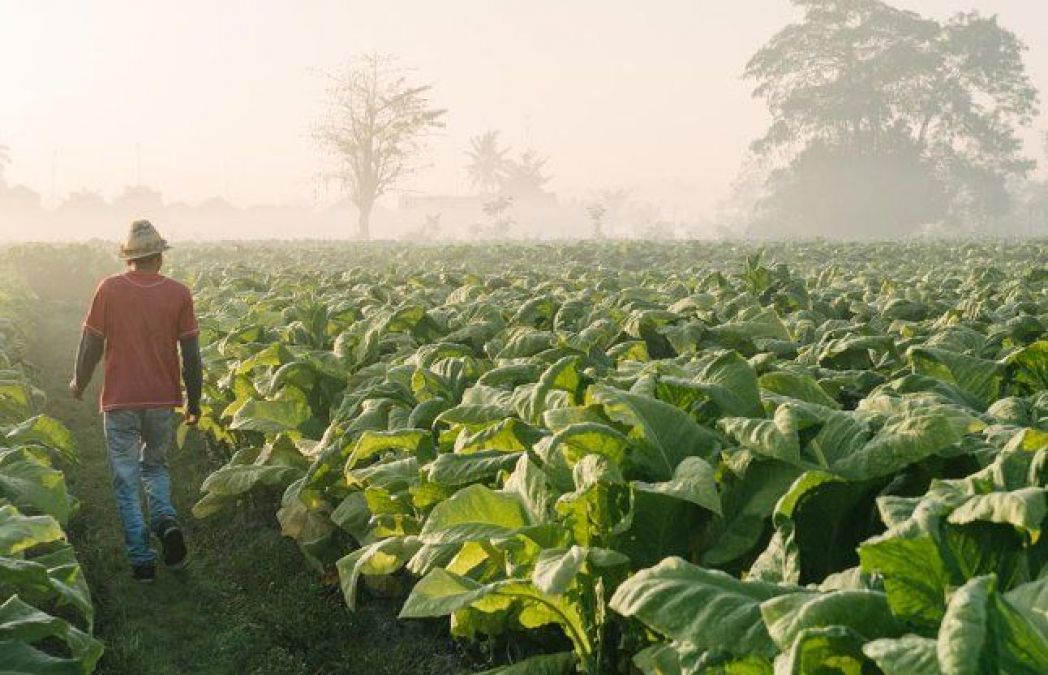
[84,270,199,411]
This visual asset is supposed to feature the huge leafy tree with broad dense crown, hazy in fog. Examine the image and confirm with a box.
[745,0,1036,236]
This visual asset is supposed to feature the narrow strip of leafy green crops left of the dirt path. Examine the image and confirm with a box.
[0,270,103,675]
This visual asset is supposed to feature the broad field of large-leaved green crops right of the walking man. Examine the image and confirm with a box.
[193,242,1048,674]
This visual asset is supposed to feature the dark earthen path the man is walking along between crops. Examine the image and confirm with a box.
[31,301,466,675]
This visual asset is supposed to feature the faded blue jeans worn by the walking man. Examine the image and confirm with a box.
[105,408,176,565]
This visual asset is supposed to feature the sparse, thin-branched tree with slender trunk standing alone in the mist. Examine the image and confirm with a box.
[315,53,445,240]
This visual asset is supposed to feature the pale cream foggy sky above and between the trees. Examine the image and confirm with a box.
[0,0,1048,217]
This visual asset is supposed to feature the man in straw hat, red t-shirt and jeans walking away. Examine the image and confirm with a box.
[69,220,203,582]
